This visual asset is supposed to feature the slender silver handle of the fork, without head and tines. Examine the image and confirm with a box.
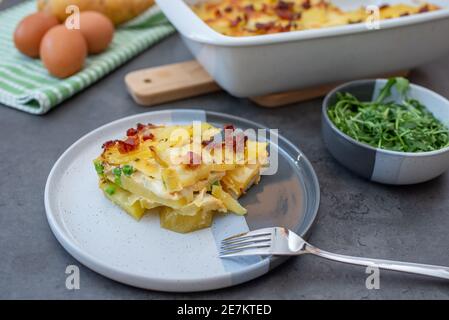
[305,245,449,279]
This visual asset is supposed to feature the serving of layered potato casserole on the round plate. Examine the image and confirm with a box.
[94,123,268,233]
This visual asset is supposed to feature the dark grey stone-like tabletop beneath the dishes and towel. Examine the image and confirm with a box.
[0,0,449,299]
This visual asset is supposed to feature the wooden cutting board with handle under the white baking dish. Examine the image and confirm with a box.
[125,60,409,108]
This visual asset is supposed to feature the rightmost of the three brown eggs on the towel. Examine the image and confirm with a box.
[80,11,114,54]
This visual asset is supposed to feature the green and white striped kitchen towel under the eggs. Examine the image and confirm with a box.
[0,0,174,114]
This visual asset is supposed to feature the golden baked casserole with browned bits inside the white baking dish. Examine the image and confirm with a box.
[192,0,439,37]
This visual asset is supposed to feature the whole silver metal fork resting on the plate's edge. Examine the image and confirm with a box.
[220,228,449,279]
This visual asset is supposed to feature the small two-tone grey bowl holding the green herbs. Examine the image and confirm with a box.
[322,79,449,185]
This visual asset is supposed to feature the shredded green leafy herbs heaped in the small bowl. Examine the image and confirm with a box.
[328,78,449,152]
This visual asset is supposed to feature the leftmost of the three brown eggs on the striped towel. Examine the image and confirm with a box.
[14,12,59,58]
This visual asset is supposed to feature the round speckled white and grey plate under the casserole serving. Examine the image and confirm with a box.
[45,110,320,292]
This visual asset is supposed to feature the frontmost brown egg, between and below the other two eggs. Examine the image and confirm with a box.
[40,25,87,78]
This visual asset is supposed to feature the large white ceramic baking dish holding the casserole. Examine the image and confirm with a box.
[156,0,449,97]
